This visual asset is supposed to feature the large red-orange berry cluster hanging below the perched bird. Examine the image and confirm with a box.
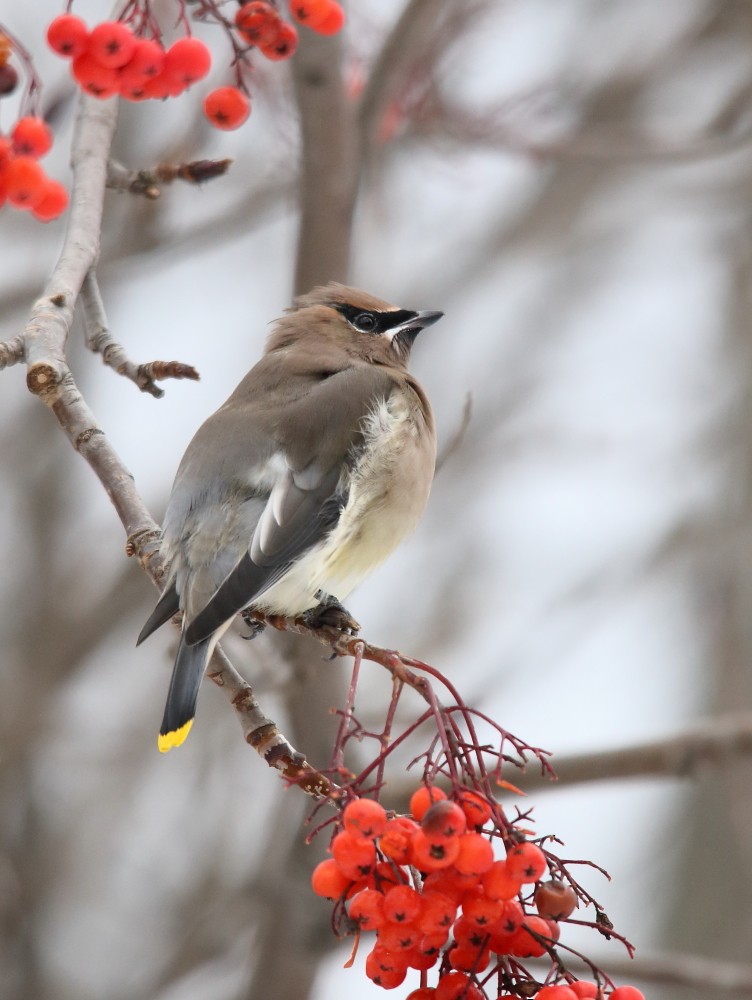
[312,786,644,1000]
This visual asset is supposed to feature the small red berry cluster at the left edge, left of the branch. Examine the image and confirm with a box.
[0,115,68,222]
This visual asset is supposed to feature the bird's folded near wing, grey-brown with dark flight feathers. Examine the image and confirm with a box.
[185,368,393,644]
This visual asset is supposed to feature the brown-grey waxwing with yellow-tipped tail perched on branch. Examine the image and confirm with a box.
[137,282,444,752]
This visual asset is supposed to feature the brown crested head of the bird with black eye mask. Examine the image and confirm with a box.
[267,281,444,367]
